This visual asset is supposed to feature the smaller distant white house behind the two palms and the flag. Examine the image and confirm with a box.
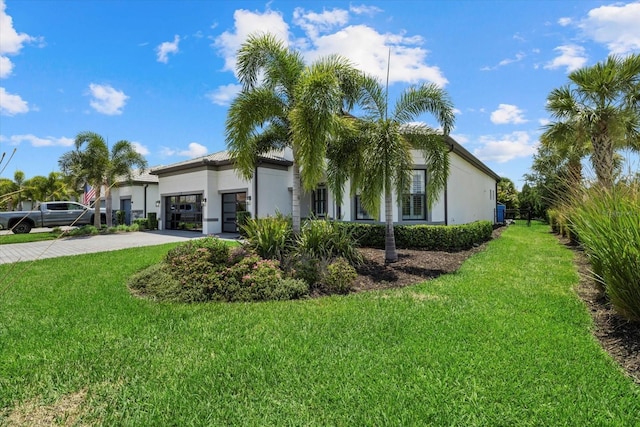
[109,171,160,225]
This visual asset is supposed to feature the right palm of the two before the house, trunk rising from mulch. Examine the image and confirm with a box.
[327,77,455,262]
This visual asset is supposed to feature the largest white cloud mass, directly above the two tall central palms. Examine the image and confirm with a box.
[214,8,448,86]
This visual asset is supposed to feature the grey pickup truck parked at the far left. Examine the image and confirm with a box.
[0,202,107,234]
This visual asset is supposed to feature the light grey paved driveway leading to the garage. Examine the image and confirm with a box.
[0,230,237,264]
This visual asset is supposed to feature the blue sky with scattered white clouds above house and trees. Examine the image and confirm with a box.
[0,0,640,188]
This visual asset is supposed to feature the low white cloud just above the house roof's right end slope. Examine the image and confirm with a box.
[473,131,538,163]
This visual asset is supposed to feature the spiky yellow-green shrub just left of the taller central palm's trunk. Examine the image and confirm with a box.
[241,214,292,260]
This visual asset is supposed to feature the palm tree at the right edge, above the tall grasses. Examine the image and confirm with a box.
[545,54,640,189]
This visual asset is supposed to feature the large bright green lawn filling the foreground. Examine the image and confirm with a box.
[0,224,640,426]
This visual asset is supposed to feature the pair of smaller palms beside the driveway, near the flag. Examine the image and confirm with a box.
[58,132,147,227]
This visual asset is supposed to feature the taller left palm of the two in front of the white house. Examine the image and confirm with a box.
[226,34,360,233]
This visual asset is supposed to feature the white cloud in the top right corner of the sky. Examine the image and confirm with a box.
[578,2,640,54]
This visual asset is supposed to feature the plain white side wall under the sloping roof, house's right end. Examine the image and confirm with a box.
[447,153,496,225]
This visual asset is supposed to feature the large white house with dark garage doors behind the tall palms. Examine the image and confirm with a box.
[150,138,500,234]
